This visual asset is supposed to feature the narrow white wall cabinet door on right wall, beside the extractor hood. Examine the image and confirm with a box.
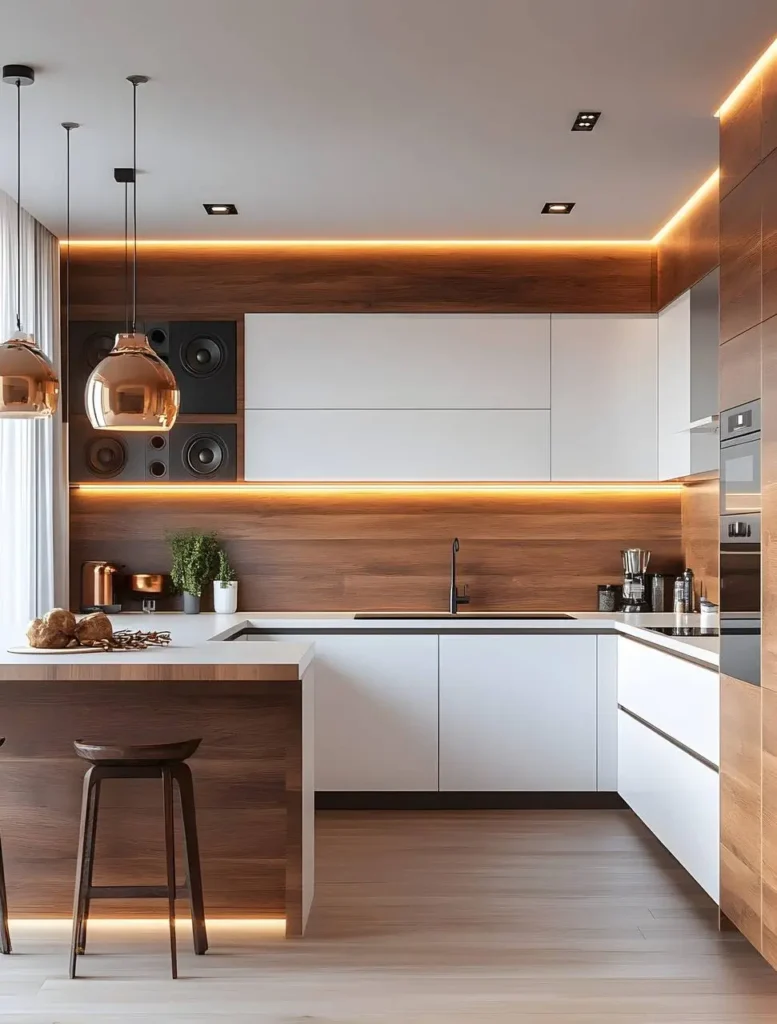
[658,292,691,480]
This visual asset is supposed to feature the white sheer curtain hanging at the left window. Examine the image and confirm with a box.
[0,191,68,643]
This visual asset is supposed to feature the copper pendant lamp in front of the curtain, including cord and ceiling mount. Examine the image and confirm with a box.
[0,65,59,420]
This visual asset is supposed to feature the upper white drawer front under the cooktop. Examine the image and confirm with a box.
[618,637,721,765]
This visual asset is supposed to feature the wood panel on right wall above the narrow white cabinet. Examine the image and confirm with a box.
[656,180,720,309]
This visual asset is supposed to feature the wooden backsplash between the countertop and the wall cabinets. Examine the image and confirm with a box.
[71,489,683,611]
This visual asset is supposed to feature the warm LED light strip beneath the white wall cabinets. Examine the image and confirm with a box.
[72,481,682,498]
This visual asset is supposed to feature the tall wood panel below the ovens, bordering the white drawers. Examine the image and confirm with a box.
[721,675,762,950]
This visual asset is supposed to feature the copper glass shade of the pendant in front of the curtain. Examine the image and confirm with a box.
[0,331,59,420]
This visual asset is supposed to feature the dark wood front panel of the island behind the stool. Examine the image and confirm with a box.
[0,671,312,935]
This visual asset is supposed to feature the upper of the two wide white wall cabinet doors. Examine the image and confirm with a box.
[246,313,551,410]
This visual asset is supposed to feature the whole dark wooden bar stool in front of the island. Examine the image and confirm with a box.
[70,739,208,978]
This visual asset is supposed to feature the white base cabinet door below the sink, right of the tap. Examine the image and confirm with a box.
[440,634,597,792]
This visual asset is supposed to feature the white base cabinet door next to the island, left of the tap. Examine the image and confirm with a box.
[269,634,437,793]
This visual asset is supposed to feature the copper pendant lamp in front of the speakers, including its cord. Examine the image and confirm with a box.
[86,75,181,433]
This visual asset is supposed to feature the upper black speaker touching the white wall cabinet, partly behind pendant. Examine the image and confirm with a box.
[166,321,238,416]
